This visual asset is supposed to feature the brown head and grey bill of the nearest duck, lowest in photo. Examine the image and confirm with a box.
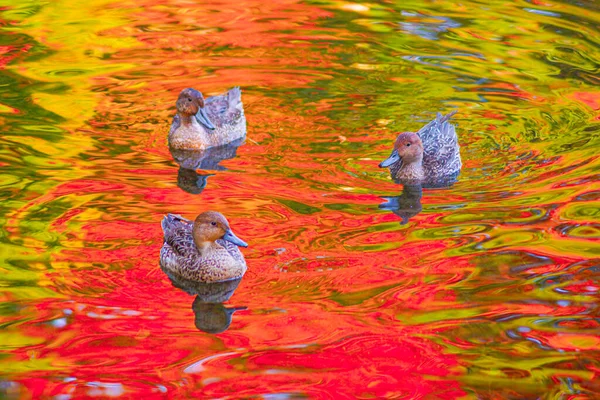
[192,211,248,251]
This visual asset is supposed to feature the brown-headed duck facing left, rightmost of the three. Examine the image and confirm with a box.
[379,110,462,184]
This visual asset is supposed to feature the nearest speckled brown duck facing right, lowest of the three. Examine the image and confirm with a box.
[160,211,248,283]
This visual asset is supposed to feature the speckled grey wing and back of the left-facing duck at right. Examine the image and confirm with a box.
[417,110,462,177]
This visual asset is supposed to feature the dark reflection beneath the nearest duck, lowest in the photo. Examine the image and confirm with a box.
[163,269,247,334]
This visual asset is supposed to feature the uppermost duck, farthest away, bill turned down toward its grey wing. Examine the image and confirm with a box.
[169,87,246,150]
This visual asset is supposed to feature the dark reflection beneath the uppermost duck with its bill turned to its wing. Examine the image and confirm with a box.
[169,138,244,194]
